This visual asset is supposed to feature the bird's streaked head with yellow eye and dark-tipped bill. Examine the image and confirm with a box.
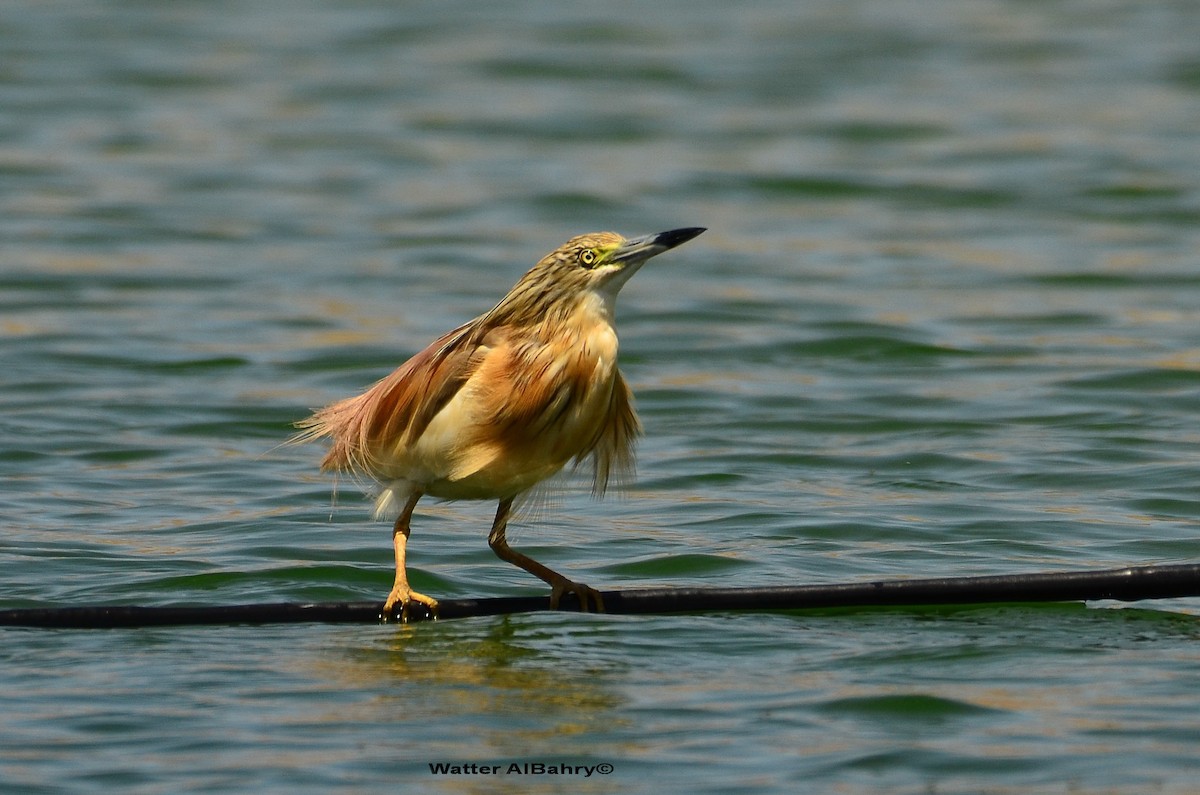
[497,227,704,326]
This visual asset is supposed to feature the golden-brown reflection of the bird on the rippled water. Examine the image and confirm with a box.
[317,617,629,763]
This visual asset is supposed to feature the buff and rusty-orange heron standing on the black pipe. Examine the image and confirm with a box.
[292,227,706,622]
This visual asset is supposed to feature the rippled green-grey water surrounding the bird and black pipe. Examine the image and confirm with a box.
[0,0,1200,794]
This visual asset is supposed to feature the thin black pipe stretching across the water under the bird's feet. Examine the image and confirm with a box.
[0,563,1200,629]
